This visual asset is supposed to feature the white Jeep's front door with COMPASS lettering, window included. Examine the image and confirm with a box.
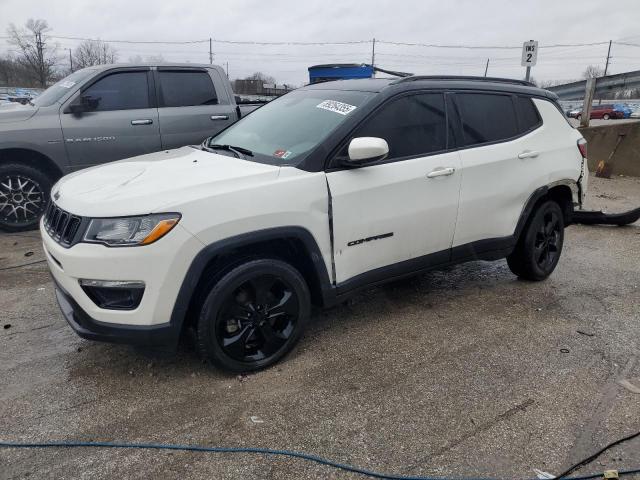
[327,93,461,289]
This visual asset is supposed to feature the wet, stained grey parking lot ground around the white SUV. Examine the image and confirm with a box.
[0,177,640,479]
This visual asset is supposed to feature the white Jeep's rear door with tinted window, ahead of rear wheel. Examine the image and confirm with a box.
[453,92,555,251]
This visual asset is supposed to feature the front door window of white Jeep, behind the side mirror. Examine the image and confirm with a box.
[345,93,447,159]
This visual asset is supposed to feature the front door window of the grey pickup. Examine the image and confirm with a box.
[82,72,149,112]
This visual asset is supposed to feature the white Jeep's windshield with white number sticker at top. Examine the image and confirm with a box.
[209,90,374,165]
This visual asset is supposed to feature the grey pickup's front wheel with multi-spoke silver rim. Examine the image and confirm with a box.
[0,163,53,232]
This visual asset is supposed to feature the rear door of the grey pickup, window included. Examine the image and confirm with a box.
[155,67,238,148]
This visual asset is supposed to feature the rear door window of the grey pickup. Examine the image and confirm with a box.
[158,71,218,107]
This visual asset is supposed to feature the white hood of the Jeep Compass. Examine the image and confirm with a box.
[52,147,280,217]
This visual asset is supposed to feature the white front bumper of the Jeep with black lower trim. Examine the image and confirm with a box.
[40,216,202,344]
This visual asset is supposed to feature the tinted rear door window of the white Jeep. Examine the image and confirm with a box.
[456,93,518,146]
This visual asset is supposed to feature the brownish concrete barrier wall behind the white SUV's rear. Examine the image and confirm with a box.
[579,120,640,177]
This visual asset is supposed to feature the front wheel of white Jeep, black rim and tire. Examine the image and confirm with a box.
[197,258,311,373]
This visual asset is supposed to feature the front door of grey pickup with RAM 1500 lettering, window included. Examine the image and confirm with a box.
[60,67,162,170]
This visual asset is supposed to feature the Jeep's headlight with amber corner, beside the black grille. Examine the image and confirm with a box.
[83,213,180,247]
